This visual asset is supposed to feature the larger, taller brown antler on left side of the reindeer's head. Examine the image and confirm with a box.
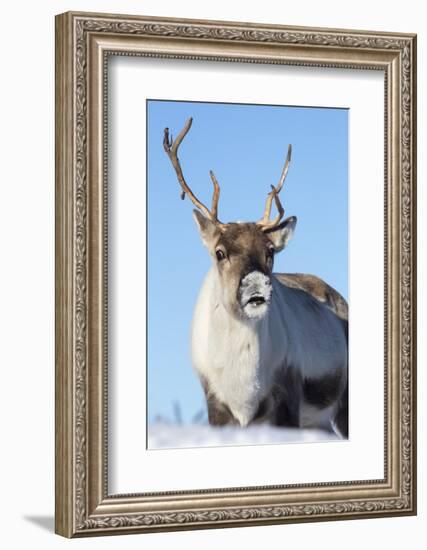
[163,117,226,227]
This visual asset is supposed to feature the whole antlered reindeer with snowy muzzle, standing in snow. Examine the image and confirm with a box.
[163,118,348,438]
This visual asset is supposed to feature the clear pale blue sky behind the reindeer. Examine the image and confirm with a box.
[147,100,348,422]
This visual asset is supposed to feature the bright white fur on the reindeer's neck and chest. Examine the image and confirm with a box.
[192,268,286,426]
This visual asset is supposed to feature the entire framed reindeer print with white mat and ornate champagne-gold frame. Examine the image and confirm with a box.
[56,12,416,537]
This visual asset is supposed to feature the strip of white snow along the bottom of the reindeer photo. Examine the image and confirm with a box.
[148,423,338,449]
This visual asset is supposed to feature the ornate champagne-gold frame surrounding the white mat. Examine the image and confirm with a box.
[55,12,416,537]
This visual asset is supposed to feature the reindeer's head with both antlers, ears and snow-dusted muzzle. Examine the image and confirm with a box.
[163,118,297,320]
